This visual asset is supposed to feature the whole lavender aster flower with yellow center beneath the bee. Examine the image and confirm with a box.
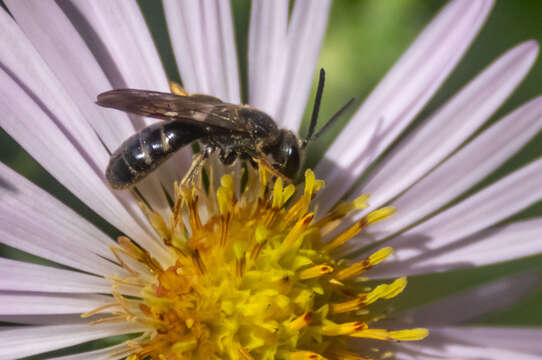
[0,0,542,360]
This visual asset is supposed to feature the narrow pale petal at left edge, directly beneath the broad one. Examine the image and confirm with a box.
[0,258,111,293]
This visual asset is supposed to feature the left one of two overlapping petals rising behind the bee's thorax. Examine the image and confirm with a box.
[248,0,289,114]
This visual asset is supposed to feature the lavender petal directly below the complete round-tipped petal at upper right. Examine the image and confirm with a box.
[371,97,542,234]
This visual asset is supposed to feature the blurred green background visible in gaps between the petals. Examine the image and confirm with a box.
[0,0,542,354]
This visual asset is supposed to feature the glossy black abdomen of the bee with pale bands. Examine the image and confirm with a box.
[105,121,205,189]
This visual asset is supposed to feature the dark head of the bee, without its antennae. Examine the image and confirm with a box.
[269,129,303,179]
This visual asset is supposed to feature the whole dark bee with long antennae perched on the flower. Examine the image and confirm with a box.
[96,69,354,189]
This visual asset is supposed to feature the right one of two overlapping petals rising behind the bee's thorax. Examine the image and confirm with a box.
[270,0,331,131]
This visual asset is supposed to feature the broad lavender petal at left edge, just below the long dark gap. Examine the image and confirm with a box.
[0,164,125,275]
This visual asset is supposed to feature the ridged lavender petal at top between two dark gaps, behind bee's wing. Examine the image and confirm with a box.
[164,0,241,104]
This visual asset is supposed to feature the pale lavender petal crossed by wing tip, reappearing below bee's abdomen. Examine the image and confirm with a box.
[7,0,169,215]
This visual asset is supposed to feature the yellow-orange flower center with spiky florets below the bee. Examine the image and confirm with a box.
[86,169,427,360]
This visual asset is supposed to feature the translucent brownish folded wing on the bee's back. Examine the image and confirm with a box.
[96,89,245,133]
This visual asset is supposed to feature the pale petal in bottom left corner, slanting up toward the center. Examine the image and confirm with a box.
[0,323,143,360]
